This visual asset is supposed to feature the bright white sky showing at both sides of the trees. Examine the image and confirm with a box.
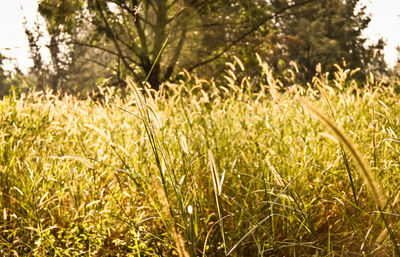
[0,0,400,71]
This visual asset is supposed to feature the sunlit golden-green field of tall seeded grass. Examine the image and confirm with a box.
[0,60,400,257]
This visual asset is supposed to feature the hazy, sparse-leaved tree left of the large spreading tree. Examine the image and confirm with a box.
[22,8,110,95]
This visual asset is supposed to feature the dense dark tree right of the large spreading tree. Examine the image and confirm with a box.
[269,0,385,81]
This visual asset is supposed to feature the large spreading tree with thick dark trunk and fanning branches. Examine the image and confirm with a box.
[39,0,315,89]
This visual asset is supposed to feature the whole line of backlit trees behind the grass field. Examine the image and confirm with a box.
[0,0,396,93]
